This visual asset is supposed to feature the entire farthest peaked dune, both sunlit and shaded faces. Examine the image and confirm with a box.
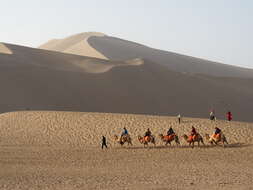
[40,33,253,78]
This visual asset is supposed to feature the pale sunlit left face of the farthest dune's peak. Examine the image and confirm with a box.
[39,32,107,59]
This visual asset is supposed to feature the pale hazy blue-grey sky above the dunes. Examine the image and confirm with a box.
[0,0,253,68]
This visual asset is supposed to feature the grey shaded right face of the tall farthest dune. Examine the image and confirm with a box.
[88,36,253,78]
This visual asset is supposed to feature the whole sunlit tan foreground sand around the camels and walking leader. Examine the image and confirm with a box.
[0,111,253,190]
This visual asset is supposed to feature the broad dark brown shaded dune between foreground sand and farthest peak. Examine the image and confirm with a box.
[0,44,253,121]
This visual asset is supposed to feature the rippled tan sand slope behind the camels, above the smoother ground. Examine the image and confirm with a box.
[0,112,253,147]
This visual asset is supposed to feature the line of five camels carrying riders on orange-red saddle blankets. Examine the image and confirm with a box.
[114,126,228,148]
